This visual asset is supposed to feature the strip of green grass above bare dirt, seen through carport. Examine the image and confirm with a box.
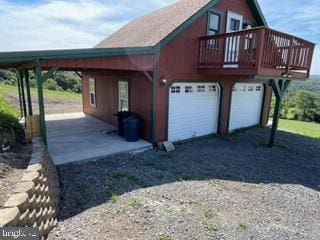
[0,84,82,101]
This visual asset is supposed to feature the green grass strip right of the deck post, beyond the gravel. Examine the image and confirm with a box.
[279,119,320,139]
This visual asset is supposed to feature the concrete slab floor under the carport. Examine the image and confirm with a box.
[46,113,152,165]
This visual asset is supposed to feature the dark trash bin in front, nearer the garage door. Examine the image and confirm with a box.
[123,115,141,142]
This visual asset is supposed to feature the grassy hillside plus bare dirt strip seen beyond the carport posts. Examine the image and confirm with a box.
[0,84,82,114]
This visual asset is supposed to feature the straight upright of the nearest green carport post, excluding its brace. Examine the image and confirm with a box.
[35,59,47,145]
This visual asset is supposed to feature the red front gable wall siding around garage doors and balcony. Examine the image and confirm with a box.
[157,0,270,142]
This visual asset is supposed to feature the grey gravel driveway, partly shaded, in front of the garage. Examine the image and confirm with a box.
[49,129,320,240]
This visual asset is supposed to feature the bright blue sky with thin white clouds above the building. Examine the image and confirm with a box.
[0,0,320,75]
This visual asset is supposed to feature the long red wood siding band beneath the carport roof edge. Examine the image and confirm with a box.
[41,56,152,71]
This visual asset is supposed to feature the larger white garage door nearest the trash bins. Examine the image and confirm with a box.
[168,83,220,142]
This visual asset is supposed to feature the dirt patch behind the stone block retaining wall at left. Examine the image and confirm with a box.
[0,144,32,207]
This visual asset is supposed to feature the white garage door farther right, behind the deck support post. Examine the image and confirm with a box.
[229,83,264,131]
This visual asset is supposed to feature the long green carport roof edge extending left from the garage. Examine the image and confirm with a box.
[0,47,154,68]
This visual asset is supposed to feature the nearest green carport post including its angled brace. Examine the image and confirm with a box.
[34,59,57,145]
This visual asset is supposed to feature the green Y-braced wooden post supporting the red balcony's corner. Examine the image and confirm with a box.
[268,79,291,147]
